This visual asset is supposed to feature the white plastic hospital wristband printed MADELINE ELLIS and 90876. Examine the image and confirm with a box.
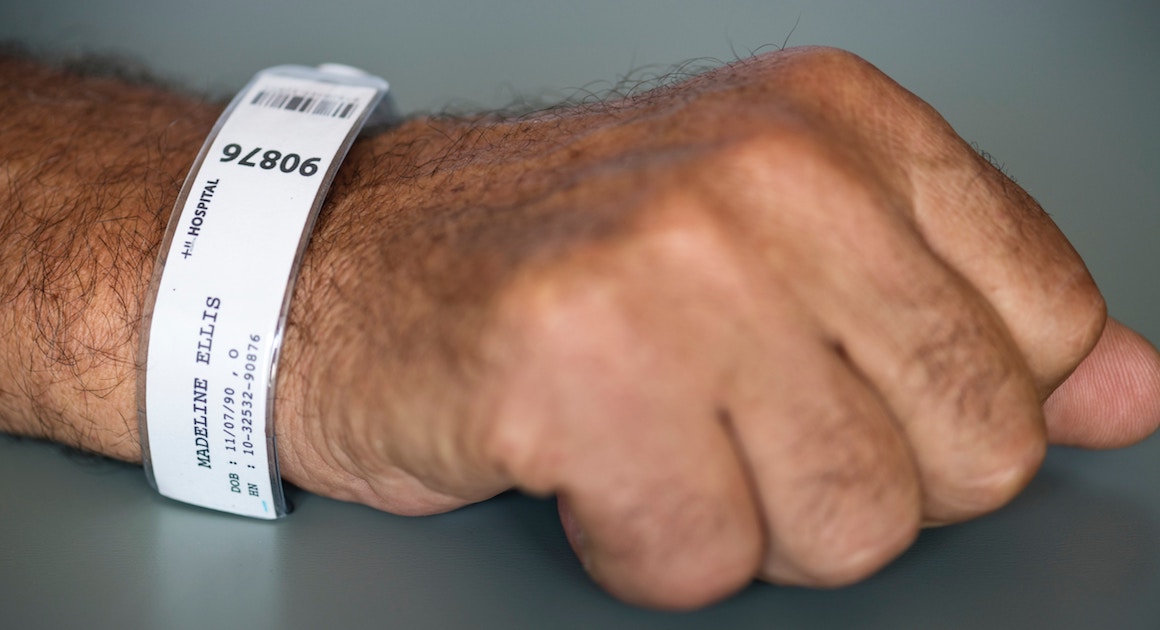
[137,64,389,519]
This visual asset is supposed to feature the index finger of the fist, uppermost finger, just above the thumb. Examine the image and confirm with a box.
[742,49,1104,400]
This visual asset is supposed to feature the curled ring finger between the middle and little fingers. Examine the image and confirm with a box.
[723,323,922,587]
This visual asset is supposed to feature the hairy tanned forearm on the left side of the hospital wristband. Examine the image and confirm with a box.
[0,59,219,461]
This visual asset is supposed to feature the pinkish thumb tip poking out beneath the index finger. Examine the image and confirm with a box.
[1043,319,1160,448]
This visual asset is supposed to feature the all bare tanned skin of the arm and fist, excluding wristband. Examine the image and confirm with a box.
[0,49,1160,608]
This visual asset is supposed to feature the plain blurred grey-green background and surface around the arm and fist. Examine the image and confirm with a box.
[0,0,1160,629]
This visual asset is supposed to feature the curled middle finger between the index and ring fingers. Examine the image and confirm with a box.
[840,263,1045,522]
